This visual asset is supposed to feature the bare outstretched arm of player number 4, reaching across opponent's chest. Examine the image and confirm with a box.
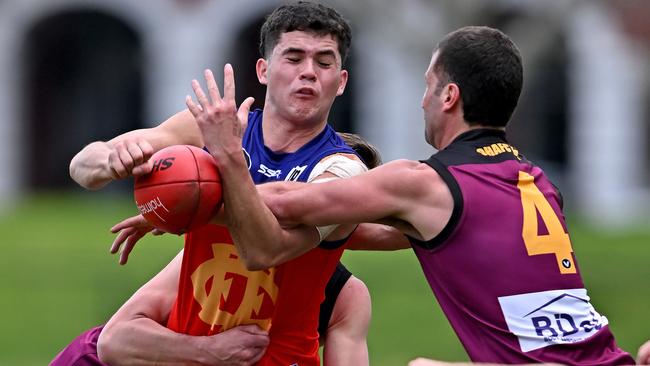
[264,160,454,240]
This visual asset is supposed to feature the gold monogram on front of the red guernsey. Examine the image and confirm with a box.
[192,243,278,331]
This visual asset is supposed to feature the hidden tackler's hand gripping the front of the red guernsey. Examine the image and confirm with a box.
[200,325,269,366]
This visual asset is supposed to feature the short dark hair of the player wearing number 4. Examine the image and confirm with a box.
[434,26,523,127]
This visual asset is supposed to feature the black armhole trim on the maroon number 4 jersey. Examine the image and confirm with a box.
[407,156,463,250]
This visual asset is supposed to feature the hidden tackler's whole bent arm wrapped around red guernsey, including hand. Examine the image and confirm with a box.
[97,252,268,366]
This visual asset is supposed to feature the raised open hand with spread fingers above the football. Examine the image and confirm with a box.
[185,64,254,164]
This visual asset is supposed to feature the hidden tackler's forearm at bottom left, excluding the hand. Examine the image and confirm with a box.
[97,317,208,366]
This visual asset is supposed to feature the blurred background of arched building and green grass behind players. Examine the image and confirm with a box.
[0,0,650,365]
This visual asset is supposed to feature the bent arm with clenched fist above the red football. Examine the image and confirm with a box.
[70,110,203,190]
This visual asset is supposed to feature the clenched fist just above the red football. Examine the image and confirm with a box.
[107,139,154,180]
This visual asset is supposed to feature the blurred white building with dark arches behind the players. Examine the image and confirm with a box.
[0,0,650,225]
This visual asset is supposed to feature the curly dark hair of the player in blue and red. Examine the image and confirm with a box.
[260,1,352,67]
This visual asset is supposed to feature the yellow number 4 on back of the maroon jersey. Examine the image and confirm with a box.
[517,171,576,274]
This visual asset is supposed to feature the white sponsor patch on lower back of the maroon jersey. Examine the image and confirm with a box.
[499,288,608,352]
